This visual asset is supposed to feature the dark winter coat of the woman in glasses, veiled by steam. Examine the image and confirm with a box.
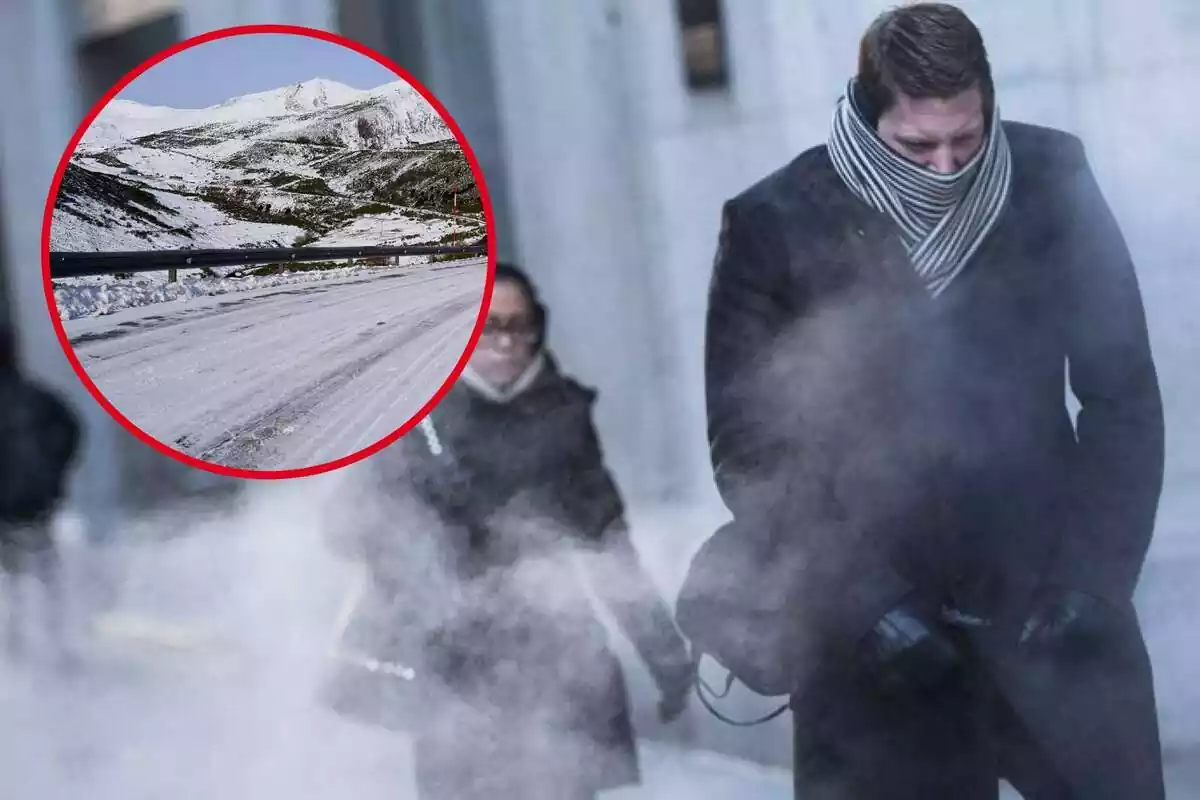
[348,359,690,798]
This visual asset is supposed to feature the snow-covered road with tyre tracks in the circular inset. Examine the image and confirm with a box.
[65,260,486,469]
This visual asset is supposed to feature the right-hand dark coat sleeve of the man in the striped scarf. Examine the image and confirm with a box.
[1049,139,1164,603]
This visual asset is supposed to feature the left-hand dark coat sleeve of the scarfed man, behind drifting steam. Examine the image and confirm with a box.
[704,200,910,649]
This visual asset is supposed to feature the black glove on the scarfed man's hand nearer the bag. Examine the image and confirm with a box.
[858,602,962,694]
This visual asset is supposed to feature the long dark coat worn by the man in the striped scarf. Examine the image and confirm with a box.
[679,122,1164,798]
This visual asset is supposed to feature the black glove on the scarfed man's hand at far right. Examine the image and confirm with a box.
[1021,587,1116,656]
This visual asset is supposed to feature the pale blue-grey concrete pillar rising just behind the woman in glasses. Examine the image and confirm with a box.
[486,0,671,498]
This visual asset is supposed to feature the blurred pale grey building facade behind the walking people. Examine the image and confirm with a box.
[0,0,1200,777]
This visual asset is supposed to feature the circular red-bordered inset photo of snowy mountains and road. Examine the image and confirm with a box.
[42,25,494,477]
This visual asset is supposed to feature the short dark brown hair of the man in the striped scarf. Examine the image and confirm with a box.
[858,2,995,118]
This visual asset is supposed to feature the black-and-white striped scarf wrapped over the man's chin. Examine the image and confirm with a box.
[828,80,1013,297]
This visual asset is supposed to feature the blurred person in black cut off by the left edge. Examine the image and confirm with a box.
[0,327,80,657]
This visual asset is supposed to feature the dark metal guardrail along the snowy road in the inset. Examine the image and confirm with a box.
[50,243,487,278]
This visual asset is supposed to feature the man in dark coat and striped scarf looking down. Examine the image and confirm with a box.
[678,4,1164,800]
